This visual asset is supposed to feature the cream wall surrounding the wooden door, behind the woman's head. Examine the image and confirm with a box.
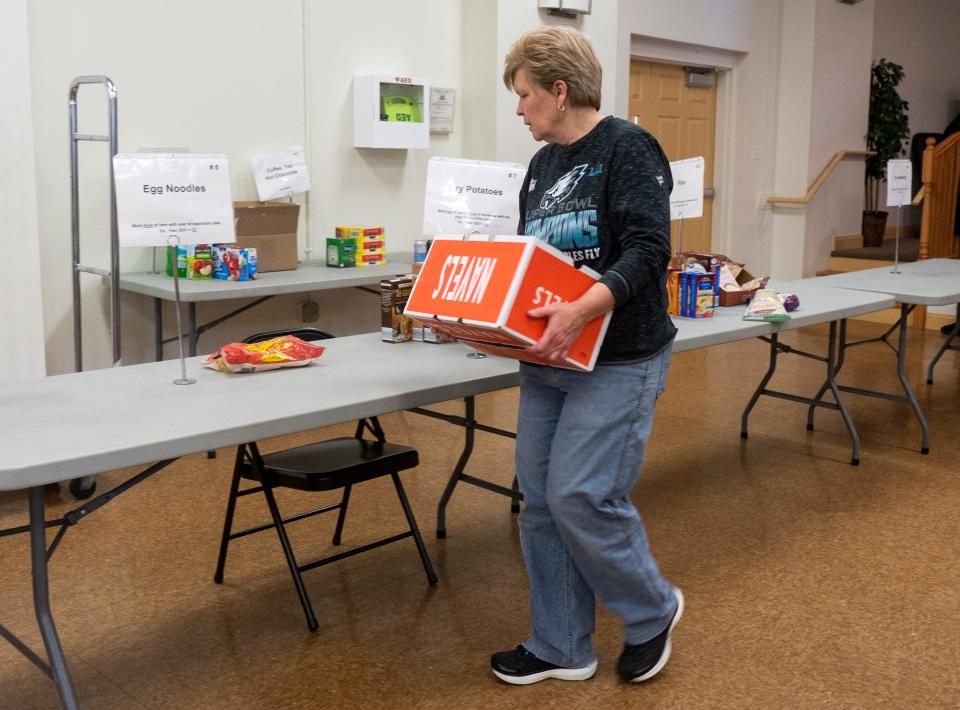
[496,0,780,271]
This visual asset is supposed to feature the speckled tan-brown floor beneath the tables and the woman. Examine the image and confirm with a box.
[0,325,960,709]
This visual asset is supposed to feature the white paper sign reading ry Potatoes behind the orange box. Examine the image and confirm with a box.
[423,158,524,235]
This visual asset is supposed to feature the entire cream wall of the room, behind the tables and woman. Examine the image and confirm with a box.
[13,0,960,373]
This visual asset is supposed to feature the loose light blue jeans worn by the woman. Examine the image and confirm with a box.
[516,345,677,667]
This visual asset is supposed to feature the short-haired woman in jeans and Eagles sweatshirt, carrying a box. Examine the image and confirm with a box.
[491,26,683,685]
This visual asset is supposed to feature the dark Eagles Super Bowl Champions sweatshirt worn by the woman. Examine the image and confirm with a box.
[518,116,676,364]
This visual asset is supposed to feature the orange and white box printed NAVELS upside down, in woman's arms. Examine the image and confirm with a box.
[404,235,610,371]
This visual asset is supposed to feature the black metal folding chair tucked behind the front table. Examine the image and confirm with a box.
[213,328,437,631]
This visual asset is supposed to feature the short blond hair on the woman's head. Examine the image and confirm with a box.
[503,25,603,111]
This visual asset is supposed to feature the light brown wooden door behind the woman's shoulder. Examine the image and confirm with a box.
[628,59,717,253]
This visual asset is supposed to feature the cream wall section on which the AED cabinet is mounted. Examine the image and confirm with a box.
[24,0,463,374]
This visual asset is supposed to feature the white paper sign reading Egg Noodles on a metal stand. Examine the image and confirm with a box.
[113,153,236,247]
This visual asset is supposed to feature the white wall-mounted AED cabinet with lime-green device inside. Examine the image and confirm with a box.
[353,75,430,148]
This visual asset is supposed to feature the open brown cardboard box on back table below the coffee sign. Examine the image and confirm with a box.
[233,201,300,272]
